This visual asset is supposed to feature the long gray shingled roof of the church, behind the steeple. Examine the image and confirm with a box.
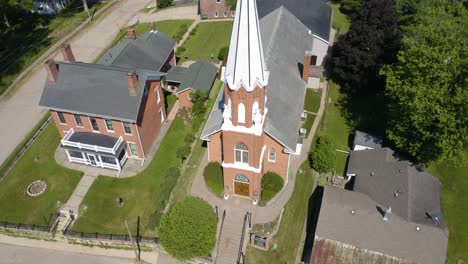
[201,7,312,152]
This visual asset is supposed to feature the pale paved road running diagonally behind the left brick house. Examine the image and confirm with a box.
[0,0,153,167]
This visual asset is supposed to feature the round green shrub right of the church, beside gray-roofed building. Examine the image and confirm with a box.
[309,136,336,173]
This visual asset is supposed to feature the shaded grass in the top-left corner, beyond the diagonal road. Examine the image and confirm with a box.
[0,1,105,94]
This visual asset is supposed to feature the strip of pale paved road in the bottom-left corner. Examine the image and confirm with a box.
[0,244,135,264]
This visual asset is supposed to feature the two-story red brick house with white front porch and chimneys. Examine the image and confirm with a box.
[39,31,173,171]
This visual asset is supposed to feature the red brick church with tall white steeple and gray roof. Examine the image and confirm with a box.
[201,0,326,202]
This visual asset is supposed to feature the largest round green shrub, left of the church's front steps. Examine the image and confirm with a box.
[159,197,218,260]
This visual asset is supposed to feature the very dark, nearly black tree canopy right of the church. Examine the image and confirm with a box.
[332,0,401,92]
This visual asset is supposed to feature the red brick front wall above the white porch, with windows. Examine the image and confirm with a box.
[50,110,144,158]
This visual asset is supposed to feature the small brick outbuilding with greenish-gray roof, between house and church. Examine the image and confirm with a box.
[166,60,218,107]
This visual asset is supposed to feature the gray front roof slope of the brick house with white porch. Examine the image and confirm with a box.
[39,62,163,122]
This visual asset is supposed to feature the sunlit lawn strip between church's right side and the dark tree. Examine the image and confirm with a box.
[320,81,354,151]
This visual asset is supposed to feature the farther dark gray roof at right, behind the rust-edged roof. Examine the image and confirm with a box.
[347,148,443,226]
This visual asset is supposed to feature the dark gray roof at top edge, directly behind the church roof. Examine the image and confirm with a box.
[257,0,332,42]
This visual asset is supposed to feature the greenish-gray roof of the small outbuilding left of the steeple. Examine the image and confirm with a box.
[166,60,218,93]
